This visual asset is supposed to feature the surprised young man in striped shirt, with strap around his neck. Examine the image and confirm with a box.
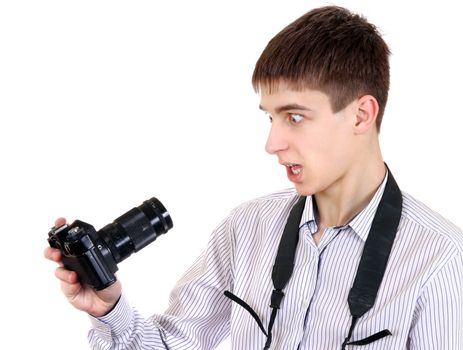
[45,6,463,350]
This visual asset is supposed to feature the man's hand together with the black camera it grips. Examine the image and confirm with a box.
[45,198,173,317]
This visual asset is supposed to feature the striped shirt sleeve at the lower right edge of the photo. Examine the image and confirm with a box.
[409,253,463,350]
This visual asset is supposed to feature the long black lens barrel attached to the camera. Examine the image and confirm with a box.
[98,197,173,263]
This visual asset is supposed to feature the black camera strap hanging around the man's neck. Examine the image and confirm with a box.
[224,171,402,350]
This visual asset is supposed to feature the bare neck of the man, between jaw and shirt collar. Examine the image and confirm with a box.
[314,157,386,227]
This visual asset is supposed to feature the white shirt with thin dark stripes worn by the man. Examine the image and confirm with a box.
[89,176,463,350]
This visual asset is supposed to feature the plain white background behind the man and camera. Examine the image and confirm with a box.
[0,0,463,350]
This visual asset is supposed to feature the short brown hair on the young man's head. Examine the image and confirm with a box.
[252,6,390,131]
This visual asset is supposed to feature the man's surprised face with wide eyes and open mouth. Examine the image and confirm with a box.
[260,84,357,195]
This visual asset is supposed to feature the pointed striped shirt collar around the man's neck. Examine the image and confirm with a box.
[299,171,388,241]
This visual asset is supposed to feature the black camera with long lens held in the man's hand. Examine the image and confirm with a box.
[48,197,173,290]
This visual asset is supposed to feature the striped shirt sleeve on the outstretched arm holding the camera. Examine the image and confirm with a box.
[88,209,236,350]
